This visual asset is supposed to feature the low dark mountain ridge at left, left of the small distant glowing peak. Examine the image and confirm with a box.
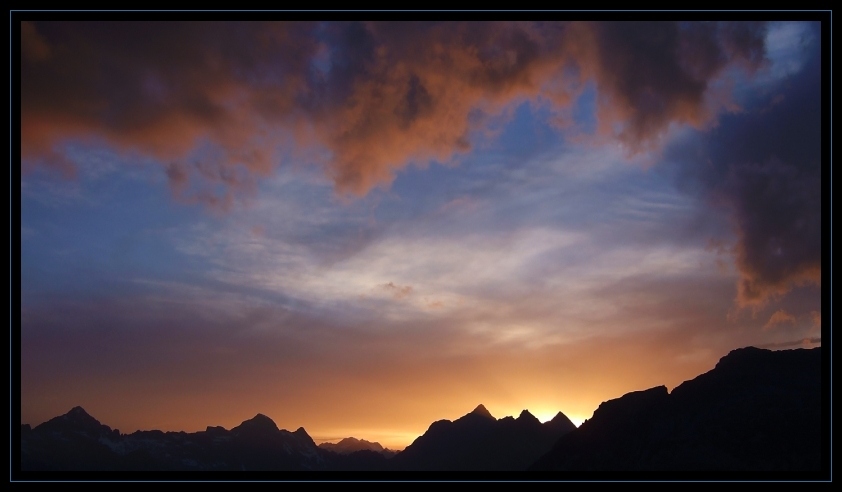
[21,407,342,471]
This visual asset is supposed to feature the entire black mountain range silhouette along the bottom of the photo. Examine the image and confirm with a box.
[18,347,829,473]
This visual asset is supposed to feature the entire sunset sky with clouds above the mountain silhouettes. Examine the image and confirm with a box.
[12,19,829,449]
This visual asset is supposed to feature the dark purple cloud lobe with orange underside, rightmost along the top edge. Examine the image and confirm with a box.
[585,22,765,150]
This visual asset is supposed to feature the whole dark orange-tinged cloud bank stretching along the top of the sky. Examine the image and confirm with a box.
[21,22,764,207]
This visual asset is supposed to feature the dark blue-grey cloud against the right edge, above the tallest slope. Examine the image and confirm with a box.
[667,24,822,306]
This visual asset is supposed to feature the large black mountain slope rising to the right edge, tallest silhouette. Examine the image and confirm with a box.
[530,347,822,471]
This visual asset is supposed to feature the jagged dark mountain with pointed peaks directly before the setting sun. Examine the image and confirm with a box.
[390,405,576,471]
